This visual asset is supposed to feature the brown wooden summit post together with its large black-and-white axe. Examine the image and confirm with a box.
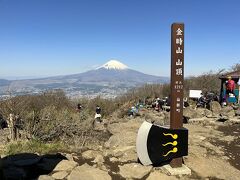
[136,23,188,168]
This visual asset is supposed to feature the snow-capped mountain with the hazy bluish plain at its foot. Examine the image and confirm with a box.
[0,60,169,97]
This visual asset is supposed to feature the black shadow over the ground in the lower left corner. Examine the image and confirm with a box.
[0,153,67,180]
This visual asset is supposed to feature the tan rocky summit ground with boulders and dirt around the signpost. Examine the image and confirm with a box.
[0,105,240,180]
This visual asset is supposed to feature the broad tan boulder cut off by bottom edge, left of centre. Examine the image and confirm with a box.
[68,164,111,180]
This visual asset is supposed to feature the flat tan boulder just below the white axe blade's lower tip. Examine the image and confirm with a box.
[118,163,152,179]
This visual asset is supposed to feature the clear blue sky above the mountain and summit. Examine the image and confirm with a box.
[0,0,240,78]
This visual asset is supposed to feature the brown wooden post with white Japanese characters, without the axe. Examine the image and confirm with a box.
[170,23,184,167]
